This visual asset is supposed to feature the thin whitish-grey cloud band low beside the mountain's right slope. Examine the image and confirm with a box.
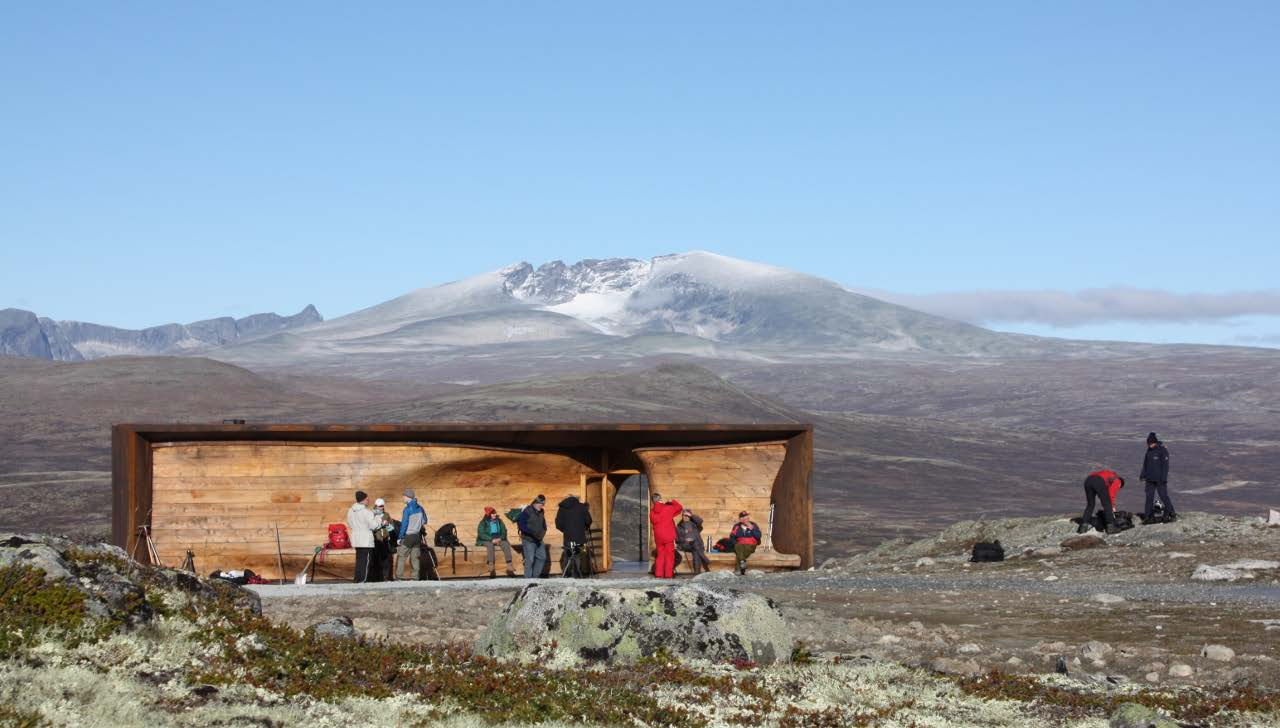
[860,288,1280,328]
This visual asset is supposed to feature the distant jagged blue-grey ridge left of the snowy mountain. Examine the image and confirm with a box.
[0,305,324,362]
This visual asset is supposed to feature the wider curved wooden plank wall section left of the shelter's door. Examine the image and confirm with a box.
[151,441,595,580]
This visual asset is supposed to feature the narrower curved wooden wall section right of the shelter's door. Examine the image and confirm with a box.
[636,443,800,566]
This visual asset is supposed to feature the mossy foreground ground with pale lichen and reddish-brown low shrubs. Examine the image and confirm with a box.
[0,559,1280,728]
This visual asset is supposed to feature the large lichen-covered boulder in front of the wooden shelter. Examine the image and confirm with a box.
[475,583,794,667]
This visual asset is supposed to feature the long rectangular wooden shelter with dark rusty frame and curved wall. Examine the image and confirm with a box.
[111,423,813,578]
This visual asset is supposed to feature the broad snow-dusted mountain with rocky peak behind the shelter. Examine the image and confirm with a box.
[202,251,1025,370]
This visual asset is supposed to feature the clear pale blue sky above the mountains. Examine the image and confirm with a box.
[0,1,1280,345]
